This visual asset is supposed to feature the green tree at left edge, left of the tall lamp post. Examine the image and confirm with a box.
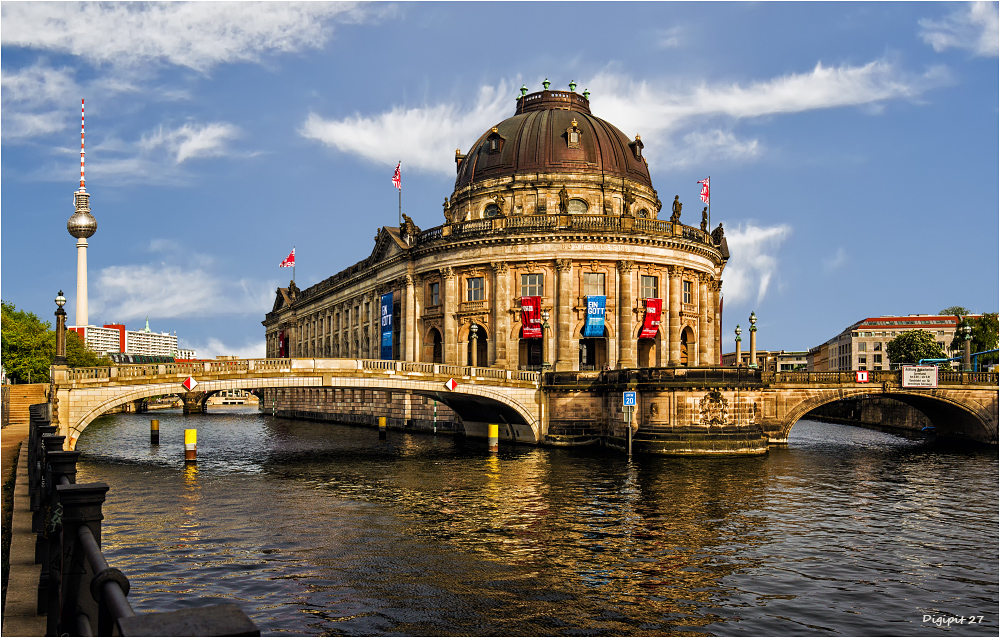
[0,301,56,383]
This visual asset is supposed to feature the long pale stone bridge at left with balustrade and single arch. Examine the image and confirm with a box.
[51,359,544,449]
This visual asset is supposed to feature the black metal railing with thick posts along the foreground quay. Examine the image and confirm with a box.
[27,404,260,636]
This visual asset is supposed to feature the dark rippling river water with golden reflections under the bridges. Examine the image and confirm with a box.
[78,408,998,636]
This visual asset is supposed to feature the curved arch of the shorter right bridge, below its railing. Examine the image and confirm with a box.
[772,388,998,443]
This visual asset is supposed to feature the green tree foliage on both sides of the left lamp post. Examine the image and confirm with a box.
[0,301,111,383]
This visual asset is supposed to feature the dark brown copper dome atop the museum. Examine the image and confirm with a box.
[455,91,653,190]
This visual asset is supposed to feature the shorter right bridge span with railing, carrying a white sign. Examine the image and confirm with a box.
[761,385,998,444]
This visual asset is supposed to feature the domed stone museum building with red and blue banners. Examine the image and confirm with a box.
[262,81,729,444]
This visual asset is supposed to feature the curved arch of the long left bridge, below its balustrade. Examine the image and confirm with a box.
[67,376,542,450]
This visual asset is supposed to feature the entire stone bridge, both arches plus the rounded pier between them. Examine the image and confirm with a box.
[45,359,998,454]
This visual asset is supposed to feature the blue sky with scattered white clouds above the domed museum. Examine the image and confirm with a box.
[0,2,1000,356]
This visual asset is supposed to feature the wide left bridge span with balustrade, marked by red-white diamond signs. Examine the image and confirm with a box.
[54,360,544,450]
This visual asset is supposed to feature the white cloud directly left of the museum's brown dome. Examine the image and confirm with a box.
[299,82,515,175]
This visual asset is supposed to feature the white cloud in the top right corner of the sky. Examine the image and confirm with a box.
[919,2,1000,57]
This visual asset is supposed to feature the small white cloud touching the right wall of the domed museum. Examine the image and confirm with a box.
[722,223,792,304]
